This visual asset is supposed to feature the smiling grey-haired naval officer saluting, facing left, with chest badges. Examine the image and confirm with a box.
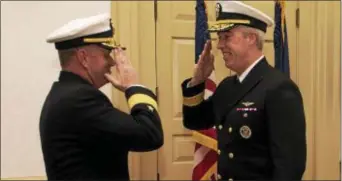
[182,1,306,180]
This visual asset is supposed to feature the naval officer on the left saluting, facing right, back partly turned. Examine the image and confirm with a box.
[40,13,163,180]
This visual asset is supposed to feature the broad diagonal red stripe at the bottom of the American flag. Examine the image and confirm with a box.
[192,147,217,181]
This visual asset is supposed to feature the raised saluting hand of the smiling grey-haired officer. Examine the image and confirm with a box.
[190,40,214,86]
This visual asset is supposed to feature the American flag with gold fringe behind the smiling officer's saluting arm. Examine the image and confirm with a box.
[192,0,217,181]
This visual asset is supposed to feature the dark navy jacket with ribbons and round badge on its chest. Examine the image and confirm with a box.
[182,58,306,180]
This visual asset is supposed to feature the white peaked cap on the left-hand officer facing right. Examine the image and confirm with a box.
[46,13,116,50]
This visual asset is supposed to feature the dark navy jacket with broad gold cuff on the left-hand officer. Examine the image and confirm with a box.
[40,71,163,180]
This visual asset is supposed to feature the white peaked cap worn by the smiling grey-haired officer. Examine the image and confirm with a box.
[208,0,273,33]
